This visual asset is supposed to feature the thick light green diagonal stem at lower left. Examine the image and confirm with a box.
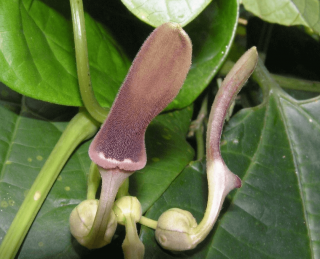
[0,112,98,259]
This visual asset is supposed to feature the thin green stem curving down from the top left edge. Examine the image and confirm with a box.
[70,0,109,123]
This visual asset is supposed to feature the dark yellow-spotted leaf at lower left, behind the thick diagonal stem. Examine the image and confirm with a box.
[0,86,194,258]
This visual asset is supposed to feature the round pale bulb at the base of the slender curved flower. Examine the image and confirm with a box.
[155,208,197,251]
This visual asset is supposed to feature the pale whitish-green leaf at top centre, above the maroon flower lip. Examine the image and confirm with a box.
[121,0,211,27]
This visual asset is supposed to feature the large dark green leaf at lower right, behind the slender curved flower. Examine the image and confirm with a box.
[141,66,320,259]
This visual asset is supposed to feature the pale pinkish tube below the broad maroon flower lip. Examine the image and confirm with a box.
[84,167,133,249]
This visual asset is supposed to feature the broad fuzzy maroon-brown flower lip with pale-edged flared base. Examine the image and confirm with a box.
[89,23,192,171]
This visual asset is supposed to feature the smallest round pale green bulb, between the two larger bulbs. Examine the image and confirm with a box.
[113,196,142,225]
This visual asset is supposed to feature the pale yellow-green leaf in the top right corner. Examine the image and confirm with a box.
[242,0,320,34]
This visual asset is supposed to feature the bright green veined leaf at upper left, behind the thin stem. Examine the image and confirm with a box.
[0,0,129,106]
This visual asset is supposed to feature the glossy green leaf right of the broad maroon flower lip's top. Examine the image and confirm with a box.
[167,0,239,109]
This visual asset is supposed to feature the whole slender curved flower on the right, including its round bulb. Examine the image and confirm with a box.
[156,47,258,251]
